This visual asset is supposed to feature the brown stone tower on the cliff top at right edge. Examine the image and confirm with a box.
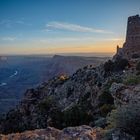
[114,15,140,59]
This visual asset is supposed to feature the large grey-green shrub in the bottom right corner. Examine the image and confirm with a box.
[108,103,140,140]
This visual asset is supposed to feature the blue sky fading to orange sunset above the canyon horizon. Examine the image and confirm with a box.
[0,0,140,55]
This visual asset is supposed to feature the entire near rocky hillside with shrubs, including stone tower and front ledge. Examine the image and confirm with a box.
[0,15,140,140]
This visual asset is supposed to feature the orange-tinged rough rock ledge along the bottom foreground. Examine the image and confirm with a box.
[0,125,100,140]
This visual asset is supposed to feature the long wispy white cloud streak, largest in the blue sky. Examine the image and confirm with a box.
[45,22,112,33]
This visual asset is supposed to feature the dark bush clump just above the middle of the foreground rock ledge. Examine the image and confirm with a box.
[48,105,93,129]
